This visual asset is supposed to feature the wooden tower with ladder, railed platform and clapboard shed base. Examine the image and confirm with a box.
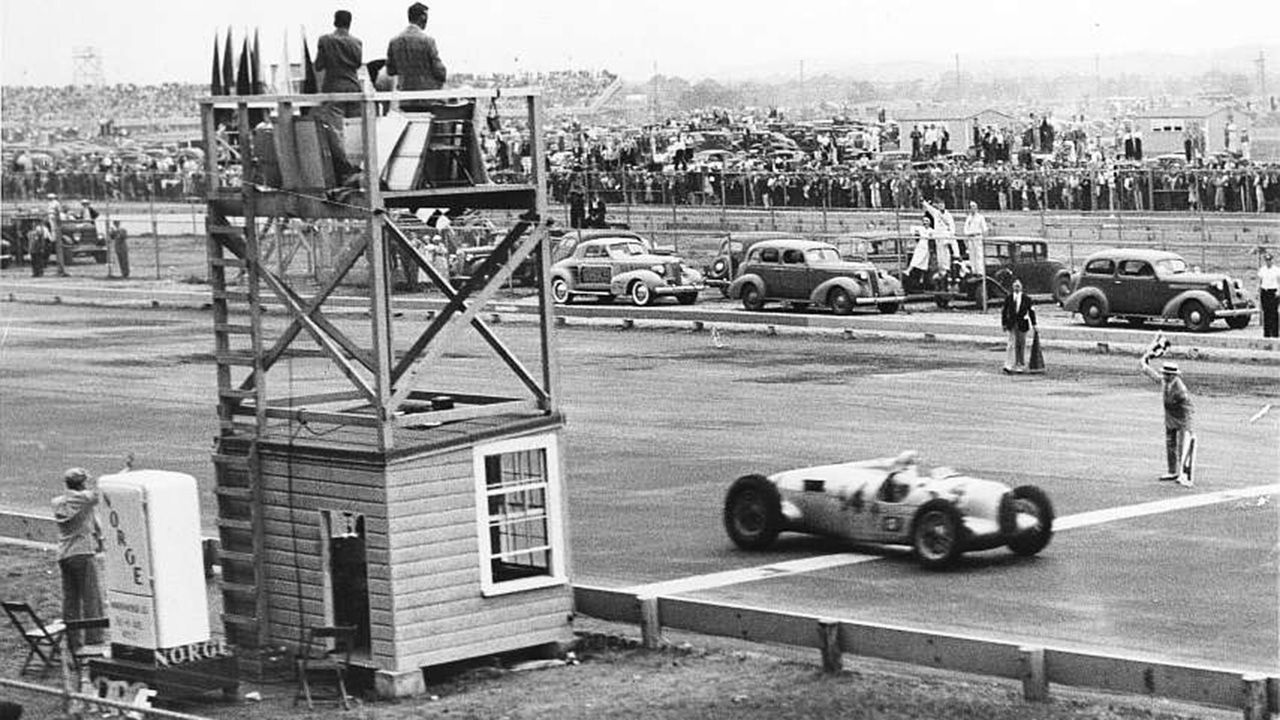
[201,88,572,696]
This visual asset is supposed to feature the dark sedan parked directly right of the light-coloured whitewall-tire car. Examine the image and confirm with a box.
[728,240,904,315]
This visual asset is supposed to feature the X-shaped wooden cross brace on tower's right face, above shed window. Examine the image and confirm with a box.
[390,215,547,411]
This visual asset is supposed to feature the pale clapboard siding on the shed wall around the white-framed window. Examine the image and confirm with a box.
[387,427,573,670]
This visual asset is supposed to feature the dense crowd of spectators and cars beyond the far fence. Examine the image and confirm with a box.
[0,79,1280,213]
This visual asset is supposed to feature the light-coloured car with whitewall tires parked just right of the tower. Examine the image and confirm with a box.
[552,237,705,306]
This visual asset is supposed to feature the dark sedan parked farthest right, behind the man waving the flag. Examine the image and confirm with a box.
[1062,249,1258,332]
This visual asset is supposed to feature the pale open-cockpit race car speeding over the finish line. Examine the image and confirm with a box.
[724,451,1053,569]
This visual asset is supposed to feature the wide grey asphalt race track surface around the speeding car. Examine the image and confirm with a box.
[0,297,1280,674]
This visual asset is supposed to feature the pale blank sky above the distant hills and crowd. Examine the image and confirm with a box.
[0,0,1280,86]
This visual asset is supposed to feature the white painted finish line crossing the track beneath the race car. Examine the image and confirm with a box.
[626,483,1280,597]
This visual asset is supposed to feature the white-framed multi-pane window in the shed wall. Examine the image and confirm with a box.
[475,436,564,594]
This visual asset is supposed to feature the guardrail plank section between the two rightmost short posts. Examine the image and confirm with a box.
[1044,648,1242,707]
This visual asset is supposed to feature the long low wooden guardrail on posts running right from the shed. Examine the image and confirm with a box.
[573,585,1280,720]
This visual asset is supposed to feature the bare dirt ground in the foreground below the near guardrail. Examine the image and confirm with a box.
[0,546,1238,720]
